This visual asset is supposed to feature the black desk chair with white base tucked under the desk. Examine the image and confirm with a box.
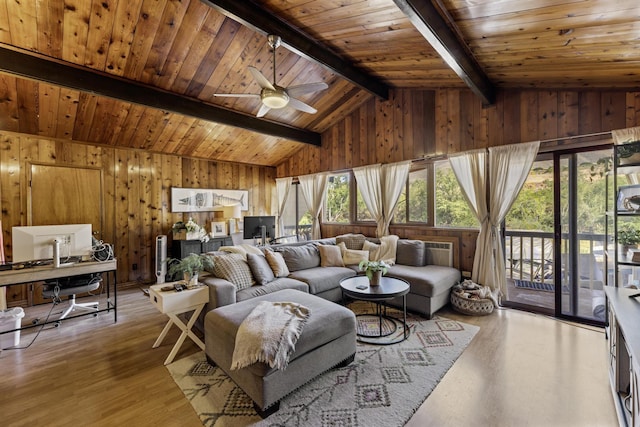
[42,273,102,327]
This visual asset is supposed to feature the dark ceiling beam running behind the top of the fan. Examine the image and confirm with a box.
[201,0,389,100]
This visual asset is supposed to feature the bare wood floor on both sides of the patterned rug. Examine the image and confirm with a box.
[0,289,617,427]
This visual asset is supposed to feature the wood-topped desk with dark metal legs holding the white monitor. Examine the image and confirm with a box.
[0,259,118,333]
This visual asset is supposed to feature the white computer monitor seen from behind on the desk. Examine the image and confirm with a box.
[11,224,93,262]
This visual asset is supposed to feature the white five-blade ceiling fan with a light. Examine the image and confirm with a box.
[214,35,329,117]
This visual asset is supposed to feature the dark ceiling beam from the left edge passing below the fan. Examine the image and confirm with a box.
[0,46,321,146]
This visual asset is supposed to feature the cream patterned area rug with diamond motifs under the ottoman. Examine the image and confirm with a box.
[167,310,479,427]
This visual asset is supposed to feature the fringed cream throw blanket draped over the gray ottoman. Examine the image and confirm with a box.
[231,301,311,370]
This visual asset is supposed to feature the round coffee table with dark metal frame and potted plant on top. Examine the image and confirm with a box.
[340,276,409,345]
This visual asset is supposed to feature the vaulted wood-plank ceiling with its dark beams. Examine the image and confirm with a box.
[0,0,640,166]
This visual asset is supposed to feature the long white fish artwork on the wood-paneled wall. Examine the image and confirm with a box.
[171,187,249,212]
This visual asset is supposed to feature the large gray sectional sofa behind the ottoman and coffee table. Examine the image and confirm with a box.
[200,235,461,318]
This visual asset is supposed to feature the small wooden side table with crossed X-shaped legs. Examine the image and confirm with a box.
[149,283,209,365]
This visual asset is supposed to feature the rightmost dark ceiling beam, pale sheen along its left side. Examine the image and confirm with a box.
[393,0,496,105]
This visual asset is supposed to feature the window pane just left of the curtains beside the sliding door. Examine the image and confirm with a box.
[435,160,479,228]
